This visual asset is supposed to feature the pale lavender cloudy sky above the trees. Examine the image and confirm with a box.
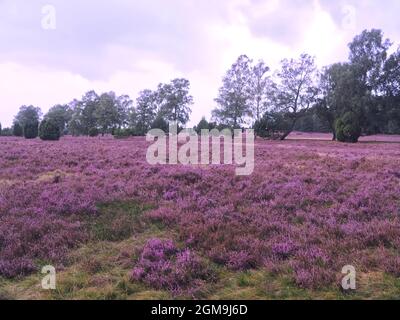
[0,0,400,127]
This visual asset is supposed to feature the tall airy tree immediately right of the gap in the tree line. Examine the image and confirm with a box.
[212,55,253,129]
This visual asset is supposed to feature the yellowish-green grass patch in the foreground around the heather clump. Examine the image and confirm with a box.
[0,202,400,300]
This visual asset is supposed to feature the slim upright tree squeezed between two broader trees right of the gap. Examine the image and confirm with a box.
[250,60,270,120]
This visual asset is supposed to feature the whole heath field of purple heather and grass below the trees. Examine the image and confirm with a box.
[0,134,400,299]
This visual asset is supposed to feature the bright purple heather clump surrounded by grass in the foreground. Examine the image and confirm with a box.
[132,239,213,294]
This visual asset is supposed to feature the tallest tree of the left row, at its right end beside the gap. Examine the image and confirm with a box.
[157,79,193,126]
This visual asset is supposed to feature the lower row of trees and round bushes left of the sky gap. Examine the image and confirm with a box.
[0,79,193,140]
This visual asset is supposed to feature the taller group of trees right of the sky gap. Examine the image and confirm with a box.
[213,29,400,142]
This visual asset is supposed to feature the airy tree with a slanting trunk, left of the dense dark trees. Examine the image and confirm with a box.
[270,54,318,140]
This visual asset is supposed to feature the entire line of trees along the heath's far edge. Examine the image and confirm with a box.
[3,29,400,142]
